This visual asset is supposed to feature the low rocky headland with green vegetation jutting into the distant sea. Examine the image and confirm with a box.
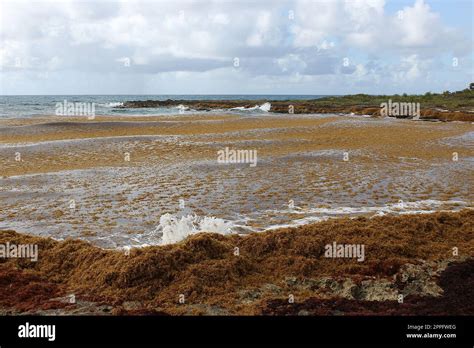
[118,89,474,122]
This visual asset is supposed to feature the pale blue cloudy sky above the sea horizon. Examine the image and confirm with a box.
[0,0,474,95]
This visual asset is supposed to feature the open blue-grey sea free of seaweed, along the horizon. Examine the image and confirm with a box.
[0,94,325,118]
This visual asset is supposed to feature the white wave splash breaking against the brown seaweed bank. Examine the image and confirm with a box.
[153,214,234,244]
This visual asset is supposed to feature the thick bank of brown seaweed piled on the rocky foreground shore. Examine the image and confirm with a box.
[0,210,474,315]
